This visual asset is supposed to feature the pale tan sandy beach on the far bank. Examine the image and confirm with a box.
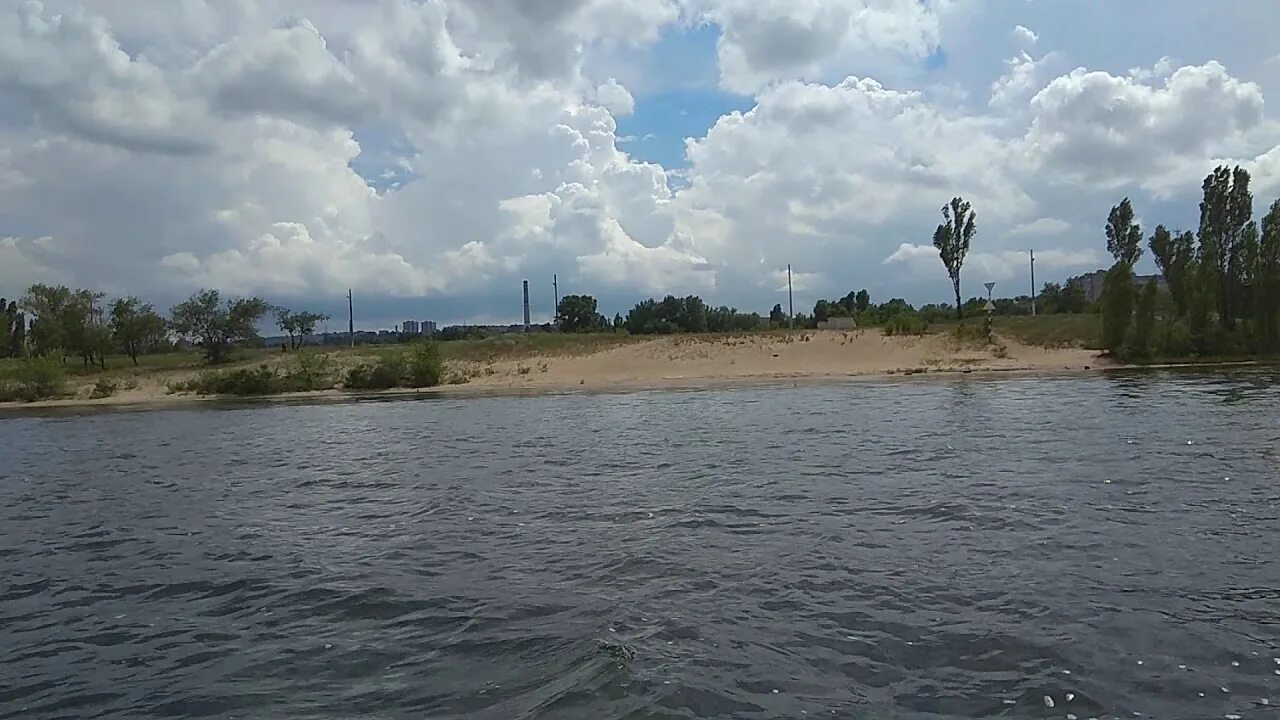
[0,331,1106,410]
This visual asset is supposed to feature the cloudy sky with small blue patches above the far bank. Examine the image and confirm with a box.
[0,0,1280,329]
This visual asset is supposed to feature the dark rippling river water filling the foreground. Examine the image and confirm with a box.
[0,372,1280,720]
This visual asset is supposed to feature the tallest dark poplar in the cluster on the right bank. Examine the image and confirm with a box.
[1199,165,1253,328]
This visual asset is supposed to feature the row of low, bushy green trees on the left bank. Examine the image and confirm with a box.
[0,284,328,369]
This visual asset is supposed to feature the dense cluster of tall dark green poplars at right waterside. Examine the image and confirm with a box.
[1101,165,1280,360]
